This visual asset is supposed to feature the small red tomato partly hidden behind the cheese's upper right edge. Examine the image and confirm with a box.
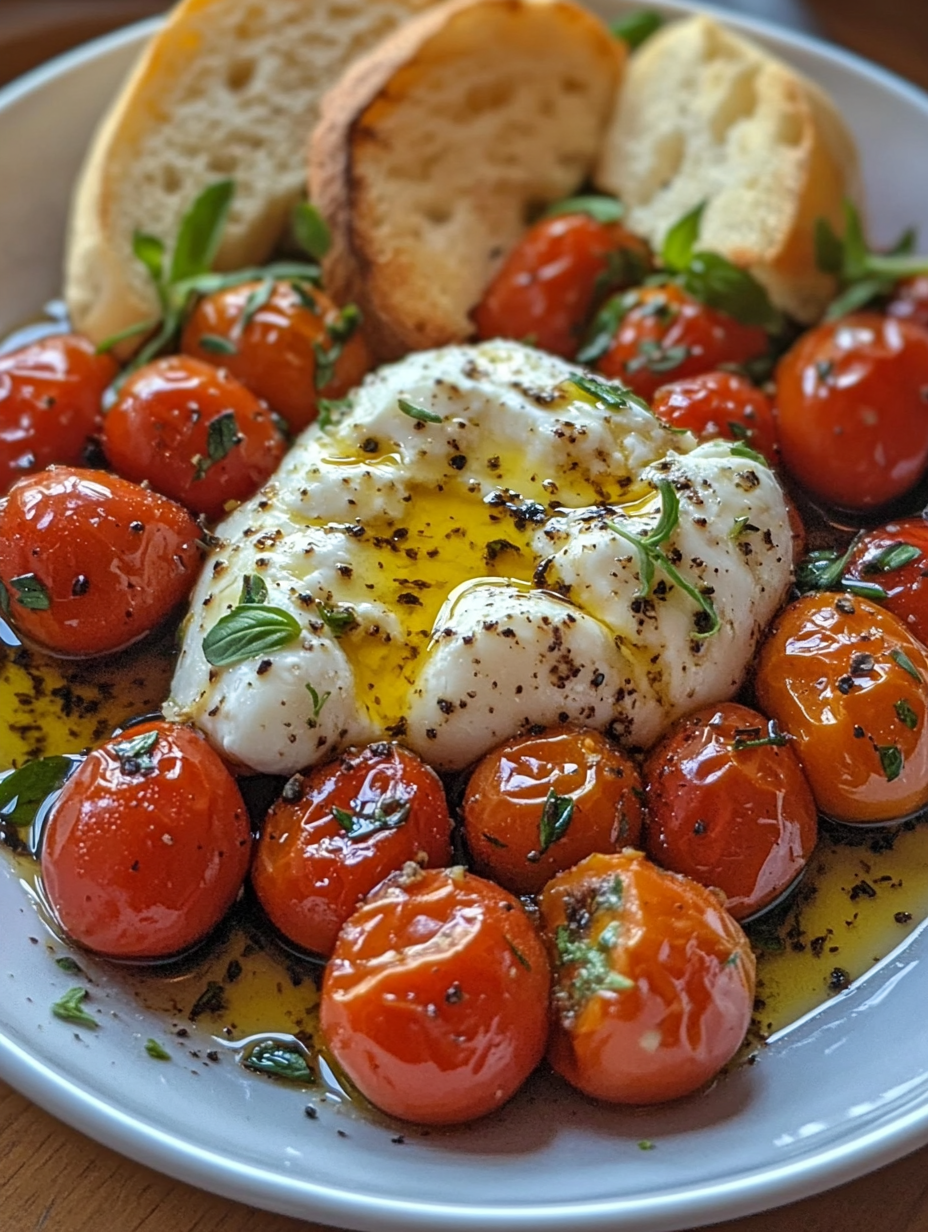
[651,372,776,461]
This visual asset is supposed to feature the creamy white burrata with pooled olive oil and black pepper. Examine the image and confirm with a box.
[168,342,792,774]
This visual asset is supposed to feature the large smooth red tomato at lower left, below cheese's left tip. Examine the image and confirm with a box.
[42,722,251,958]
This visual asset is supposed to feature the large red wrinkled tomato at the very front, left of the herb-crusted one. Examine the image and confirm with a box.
[320,865,551,1125]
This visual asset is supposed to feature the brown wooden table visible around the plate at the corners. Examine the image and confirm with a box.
[0,0,928,1232]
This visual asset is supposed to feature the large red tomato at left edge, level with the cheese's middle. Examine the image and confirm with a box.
[0,466,201,657]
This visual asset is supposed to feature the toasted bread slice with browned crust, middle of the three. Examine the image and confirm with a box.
[309,0,625,359]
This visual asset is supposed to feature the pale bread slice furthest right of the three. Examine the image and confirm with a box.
[595,16,859,323]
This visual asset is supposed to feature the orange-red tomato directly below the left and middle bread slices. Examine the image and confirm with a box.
[181,282,371,432]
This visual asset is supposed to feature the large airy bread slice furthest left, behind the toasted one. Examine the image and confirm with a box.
[65,0,433,352]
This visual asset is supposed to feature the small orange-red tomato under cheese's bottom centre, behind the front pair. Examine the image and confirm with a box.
[463,727,643,894]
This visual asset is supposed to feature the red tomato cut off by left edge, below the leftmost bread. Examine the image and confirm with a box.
[0,334,117,495]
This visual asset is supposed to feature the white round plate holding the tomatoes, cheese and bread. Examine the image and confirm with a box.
[0,2,928,1232]
